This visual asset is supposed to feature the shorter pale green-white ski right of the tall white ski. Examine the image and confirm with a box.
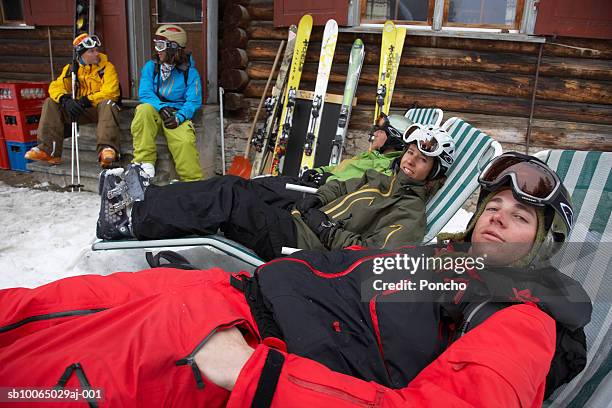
[329,38,365,166]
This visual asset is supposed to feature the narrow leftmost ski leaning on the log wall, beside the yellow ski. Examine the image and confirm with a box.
[251,25,297,177]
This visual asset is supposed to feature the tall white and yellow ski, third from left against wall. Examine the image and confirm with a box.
[300,19,338,174]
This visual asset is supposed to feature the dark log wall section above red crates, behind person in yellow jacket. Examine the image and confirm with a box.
[0,26,76,82]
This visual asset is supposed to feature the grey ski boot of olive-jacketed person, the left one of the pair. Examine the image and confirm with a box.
[96,169,134,240]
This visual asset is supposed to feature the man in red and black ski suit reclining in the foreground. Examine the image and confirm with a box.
[0,154,591,407]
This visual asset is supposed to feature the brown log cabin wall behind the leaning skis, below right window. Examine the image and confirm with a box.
[219,0,612,166]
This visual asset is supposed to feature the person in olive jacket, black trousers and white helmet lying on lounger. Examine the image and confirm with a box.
[97,122,454,260]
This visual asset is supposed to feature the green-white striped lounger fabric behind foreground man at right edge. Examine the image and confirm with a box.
[536,150,612,407]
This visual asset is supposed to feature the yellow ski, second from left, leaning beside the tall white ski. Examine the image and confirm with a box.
[270,14,312,176]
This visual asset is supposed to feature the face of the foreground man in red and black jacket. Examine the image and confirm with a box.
[471,190,538,265]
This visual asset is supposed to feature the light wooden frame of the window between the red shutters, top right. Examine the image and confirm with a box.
[354,0,537,34]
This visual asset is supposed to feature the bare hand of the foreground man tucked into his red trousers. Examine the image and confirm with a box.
[195,327,253,391]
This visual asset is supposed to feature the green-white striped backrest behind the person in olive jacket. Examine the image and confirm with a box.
[423,117,502,242]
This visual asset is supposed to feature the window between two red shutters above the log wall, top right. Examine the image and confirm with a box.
[361,0,525,30]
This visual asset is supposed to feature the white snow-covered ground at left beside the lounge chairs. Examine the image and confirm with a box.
[0,182,470,289]
